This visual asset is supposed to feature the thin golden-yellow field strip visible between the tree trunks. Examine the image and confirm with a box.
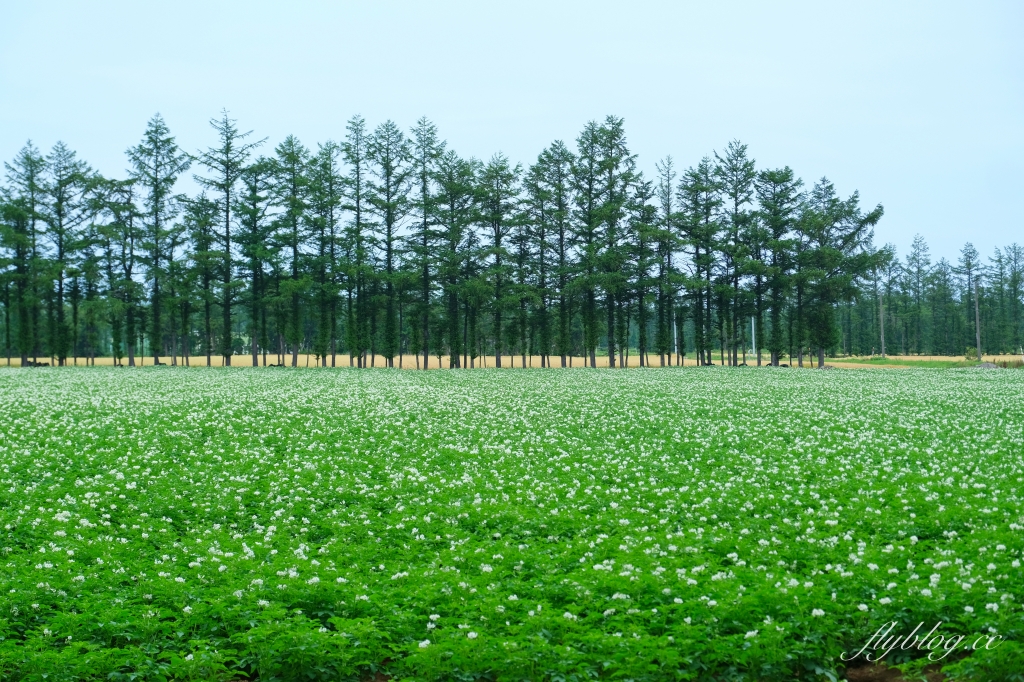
[0,353,1022,370]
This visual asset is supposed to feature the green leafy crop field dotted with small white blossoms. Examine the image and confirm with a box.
[0,368,1024,680]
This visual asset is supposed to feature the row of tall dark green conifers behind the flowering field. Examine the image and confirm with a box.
[0,112,1022,368]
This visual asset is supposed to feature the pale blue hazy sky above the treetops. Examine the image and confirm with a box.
[0,0,1024,261]
